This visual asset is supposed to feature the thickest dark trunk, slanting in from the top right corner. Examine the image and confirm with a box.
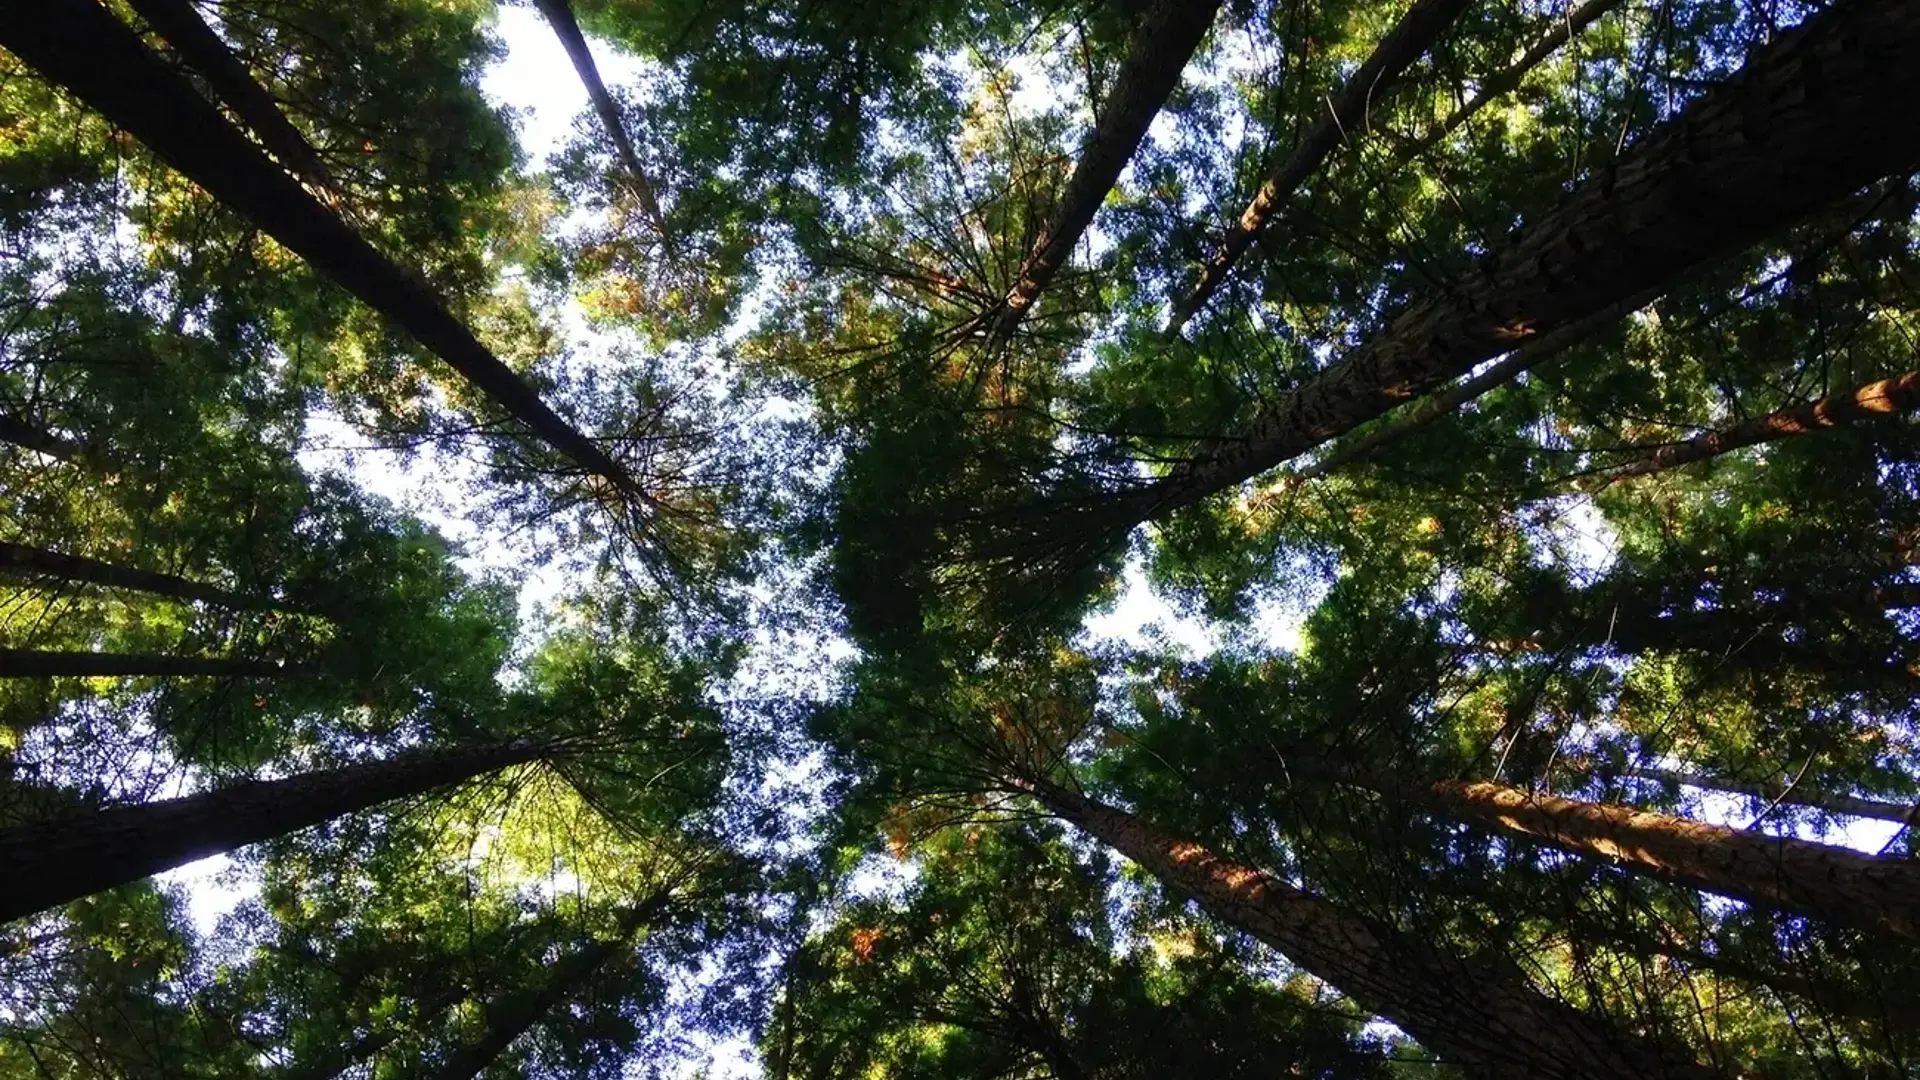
[1116,0,1920,521]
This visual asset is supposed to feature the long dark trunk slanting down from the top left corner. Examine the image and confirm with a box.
[0,0,647,502]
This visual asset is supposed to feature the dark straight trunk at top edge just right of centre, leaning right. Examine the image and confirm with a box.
[987,0,1221,342]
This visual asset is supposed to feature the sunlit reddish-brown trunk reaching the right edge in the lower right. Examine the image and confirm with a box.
[1397,776,1920,940]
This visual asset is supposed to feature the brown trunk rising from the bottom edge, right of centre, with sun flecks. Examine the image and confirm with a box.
[1016,784,1716,1080]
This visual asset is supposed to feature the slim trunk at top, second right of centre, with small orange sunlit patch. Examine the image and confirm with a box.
[1167,0,1469,336]
